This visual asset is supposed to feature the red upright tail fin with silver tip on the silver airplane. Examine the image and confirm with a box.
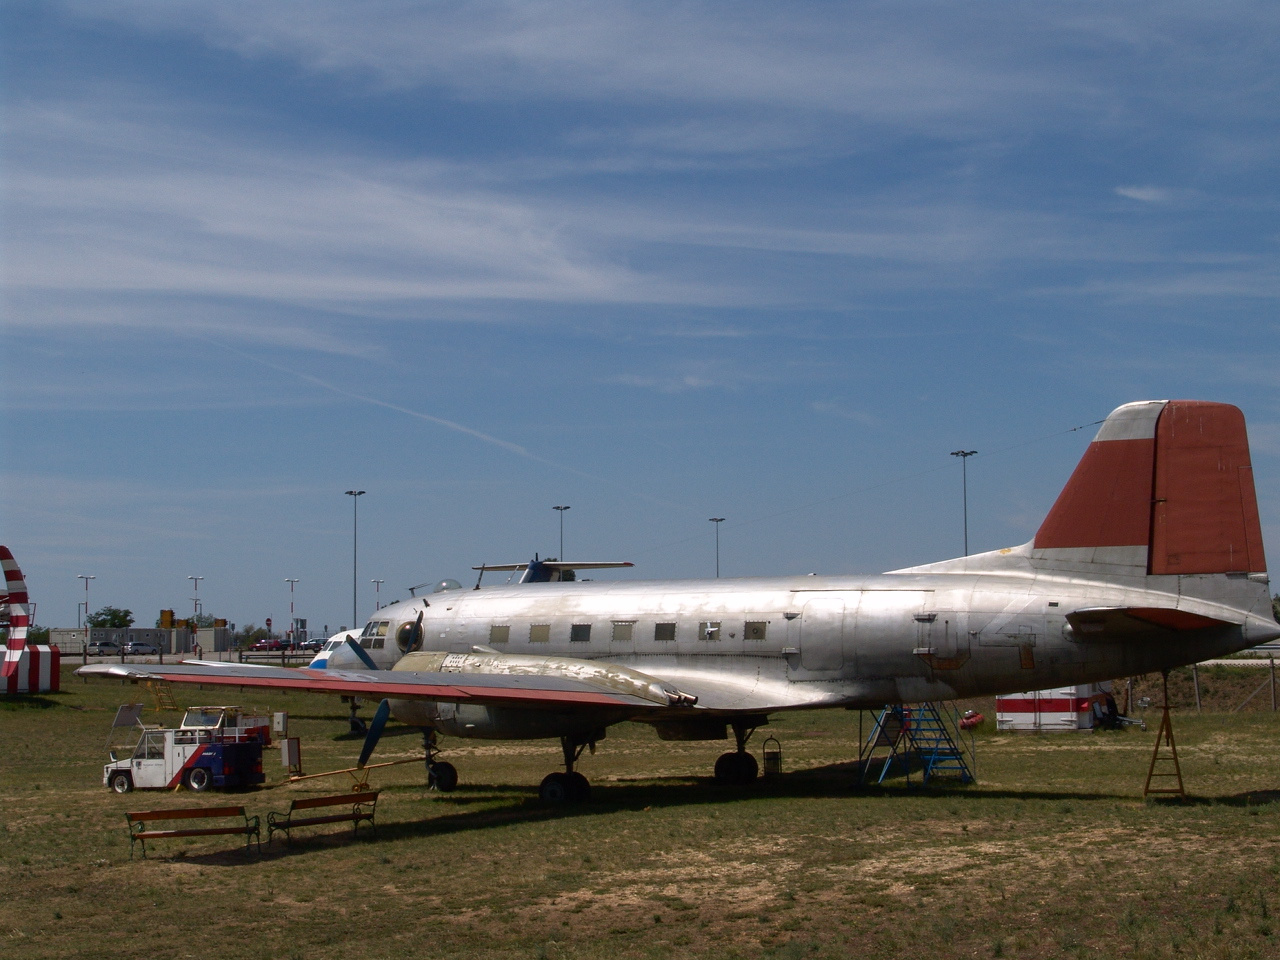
[1030,401,1267,580]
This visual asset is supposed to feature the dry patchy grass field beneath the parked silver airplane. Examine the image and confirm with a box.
[0,671,1280,960]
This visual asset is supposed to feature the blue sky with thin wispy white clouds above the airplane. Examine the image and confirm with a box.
[0,0,1280,640]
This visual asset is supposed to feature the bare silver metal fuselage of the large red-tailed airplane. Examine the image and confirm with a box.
[340,571,1260,736]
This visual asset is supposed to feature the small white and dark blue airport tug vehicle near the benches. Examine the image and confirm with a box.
[102,707,271,794]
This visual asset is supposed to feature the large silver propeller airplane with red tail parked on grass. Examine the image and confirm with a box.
[77,401,1280,800]
